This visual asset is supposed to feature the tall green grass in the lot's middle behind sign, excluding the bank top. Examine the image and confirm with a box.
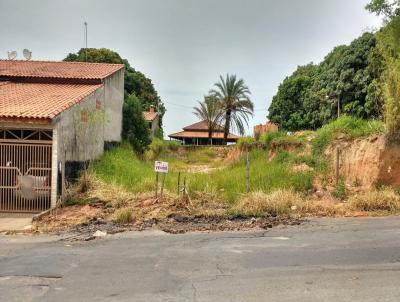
[91,145,314,203]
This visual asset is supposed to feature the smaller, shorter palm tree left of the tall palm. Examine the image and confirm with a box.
[193,96,223,144]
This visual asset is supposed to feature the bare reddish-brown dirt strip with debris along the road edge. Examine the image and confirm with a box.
[31,199,304,241]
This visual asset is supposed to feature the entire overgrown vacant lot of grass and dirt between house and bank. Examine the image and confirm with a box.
[33,117,400,232]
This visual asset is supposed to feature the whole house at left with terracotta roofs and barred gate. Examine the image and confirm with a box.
[0,60,124,212]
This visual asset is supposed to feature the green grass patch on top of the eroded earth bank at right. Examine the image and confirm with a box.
[312,115,385,155]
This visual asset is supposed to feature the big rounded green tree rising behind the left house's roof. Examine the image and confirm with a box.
[64,48,166,139]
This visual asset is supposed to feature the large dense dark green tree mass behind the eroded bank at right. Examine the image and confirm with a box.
[268,33,382,131]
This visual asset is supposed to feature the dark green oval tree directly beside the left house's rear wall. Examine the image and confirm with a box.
[122,94,151,153]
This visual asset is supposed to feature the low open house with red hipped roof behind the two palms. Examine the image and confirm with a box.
[169,121,239,145]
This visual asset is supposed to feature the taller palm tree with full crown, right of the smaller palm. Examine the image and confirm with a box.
[210,74,254,143]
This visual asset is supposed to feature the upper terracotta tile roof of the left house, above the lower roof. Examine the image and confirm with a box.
[0,60,124,80]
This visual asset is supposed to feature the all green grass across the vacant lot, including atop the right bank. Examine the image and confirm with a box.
[91,116,385,204]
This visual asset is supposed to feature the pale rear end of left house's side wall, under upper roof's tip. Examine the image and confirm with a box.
[104,70,124,142]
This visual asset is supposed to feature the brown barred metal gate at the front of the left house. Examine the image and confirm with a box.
[0,130,52,213]
